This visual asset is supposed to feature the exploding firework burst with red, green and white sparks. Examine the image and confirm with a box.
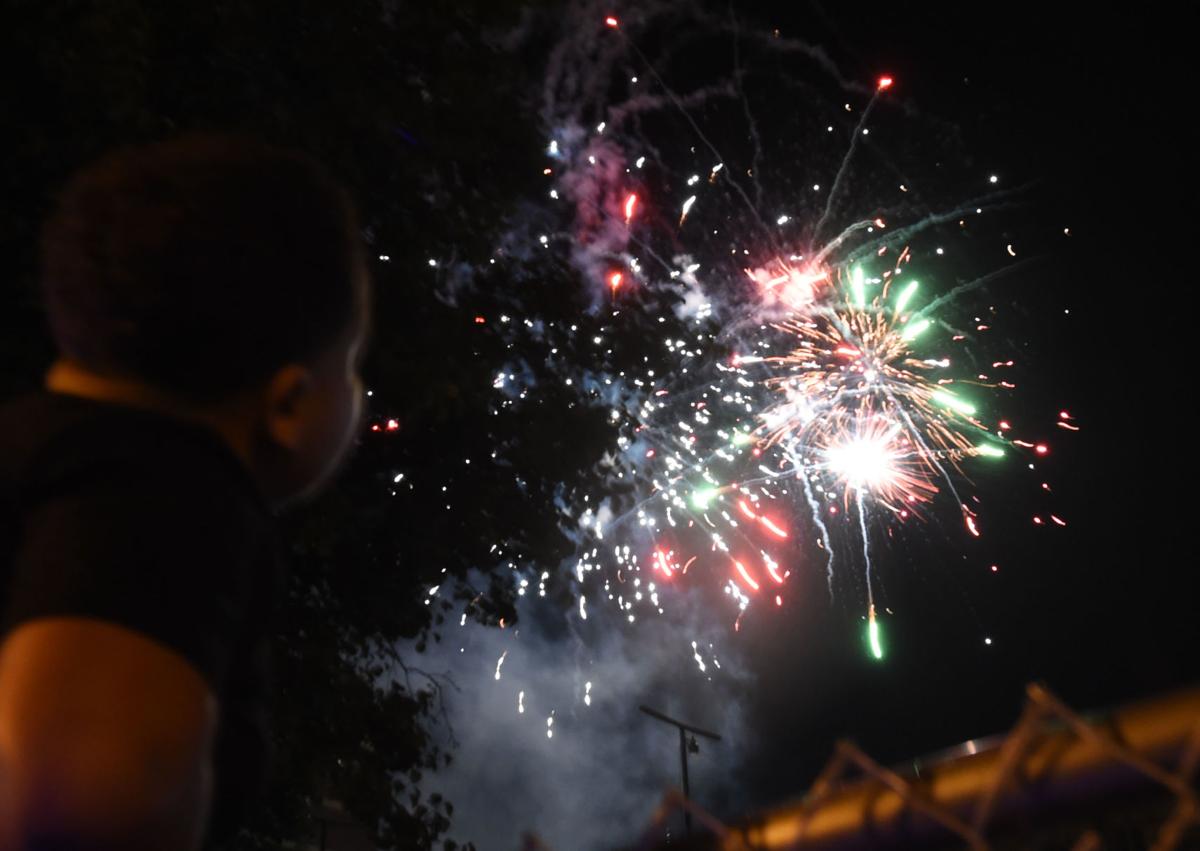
[520,1,1078,658]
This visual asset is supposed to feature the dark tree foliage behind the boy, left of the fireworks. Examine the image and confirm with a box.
[0,0,607,849]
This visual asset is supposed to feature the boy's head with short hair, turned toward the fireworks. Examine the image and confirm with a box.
[42,136,370,503]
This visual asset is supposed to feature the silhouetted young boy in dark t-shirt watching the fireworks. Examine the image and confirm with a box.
[0,137,370,851]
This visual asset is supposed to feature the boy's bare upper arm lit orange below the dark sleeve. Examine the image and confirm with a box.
[0,617,217,851]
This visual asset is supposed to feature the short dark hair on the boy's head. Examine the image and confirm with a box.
[42,136,365,401]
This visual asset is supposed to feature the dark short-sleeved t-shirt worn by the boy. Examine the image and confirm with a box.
[0,392,283,845]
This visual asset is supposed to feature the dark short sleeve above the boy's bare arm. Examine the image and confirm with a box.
[2,460,256,697]
